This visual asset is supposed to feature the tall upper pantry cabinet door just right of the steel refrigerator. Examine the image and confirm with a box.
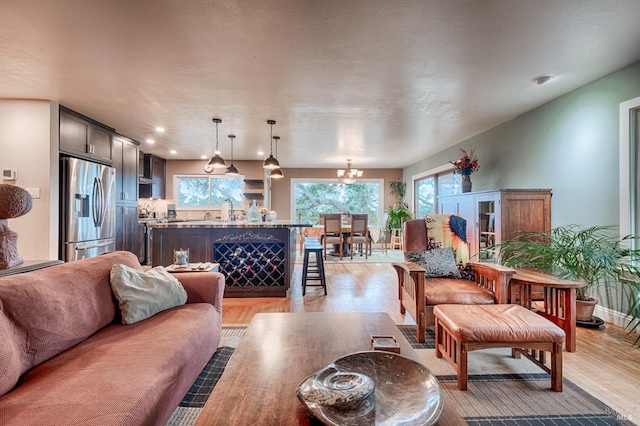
[113,135,138,203]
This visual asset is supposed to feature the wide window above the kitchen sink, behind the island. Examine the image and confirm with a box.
[173,175,244,210]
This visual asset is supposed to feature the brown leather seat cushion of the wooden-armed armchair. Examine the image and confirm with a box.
[424,278,495,305]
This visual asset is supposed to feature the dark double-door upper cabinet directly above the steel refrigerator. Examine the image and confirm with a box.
[60,107,115,163]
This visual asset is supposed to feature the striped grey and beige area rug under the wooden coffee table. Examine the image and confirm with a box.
[167,325,633,426]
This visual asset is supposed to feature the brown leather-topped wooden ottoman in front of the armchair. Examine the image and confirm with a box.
[433,304,565,392]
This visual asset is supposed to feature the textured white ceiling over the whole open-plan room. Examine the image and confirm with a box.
[0,0,640,168]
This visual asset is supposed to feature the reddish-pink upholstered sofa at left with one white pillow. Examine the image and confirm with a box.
[0,252,224,426]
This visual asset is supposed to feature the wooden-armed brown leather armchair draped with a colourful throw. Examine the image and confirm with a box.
[393,219,516,342]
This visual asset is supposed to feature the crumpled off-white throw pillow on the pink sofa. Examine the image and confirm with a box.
[111,264,187,324]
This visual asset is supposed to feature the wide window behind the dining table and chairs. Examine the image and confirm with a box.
[291,179,384,225]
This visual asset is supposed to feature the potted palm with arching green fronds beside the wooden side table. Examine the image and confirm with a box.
[494,224,640,326]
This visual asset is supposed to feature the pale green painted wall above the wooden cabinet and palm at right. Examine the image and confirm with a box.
[403,62,640,226]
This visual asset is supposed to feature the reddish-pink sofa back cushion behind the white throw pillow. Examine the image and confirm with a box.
[0,252,140,395]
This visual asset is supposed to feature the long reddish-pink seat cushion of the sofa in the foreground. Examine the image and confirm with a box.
[0,303,222,426]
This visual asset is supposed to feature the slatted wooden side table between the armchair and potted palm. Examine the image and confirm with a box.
[508,269,584,352]
